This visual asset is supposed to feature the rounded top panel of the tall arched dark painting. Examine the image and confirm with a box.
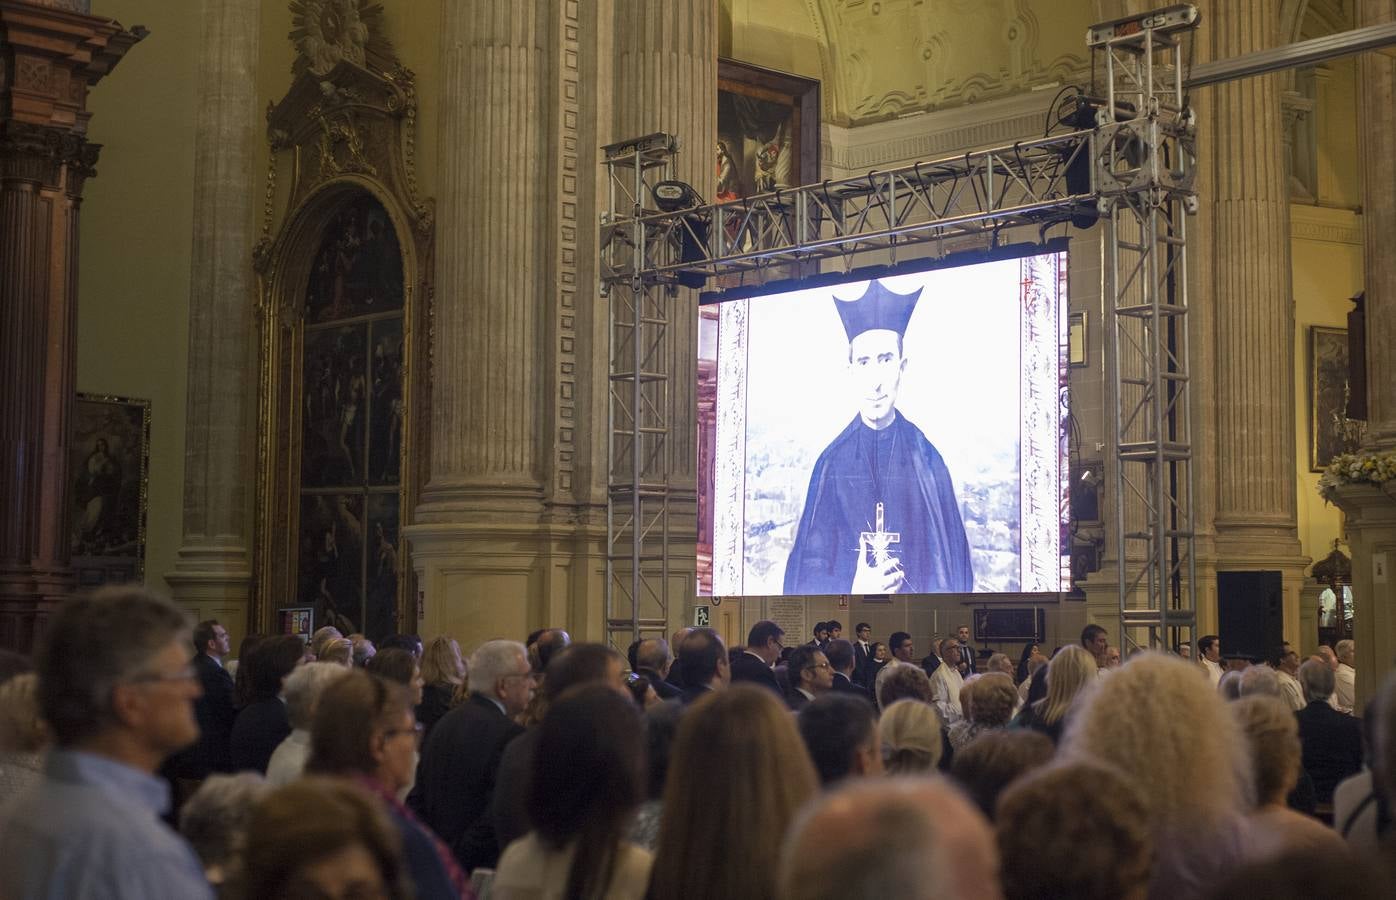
[306,194,402,325]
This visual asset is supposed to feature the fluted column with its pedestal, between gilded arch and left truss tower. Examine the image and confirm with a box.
[403,0,566,645]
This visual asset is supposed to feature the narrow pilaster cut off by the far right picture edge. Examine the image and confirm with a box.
[1357,0,1396,449]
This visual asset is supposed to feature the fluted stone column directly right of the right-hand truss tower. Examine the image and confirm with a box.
[1194,0,1308,643]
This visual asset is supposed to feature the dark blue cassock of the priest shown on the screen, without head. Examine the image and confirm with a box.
[785,413,974,594]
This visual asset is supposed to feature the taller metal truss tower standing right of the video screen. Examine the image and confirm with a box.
[1087,7,1198,649]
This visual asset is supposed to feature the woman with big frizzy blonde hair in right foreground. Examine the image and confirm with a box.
[1053,653,1252,900]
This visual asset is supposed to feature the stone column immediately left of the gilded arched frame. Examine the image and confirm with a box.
[165,0,262,639]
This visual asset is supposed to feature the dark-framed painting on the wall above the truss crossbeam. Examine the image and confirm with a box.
[713,60,819,202]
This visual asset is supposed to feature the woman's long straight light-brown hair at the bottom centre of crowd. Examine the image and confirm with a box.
[649,684,819,900]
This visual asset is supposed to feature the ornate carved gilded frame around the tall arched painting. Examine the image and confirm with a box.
[253,28,434,629]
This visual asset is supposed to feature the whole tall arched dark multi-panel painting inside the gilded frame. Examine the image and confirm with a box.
[288,194,406,639]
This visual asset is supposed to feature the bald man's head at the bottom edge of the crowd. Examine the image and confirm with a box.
[779,779,1002,900]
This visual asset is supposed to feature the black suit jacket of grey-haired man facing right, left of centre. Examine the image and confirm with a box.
[408,693,524,872]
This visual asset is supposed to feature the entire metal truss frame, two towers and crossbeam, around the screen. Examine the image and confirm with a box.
[600,6,1198,646]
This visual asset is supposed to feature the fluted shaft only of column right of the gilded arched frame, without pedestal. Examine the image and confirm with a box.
[417,0,557,522]
